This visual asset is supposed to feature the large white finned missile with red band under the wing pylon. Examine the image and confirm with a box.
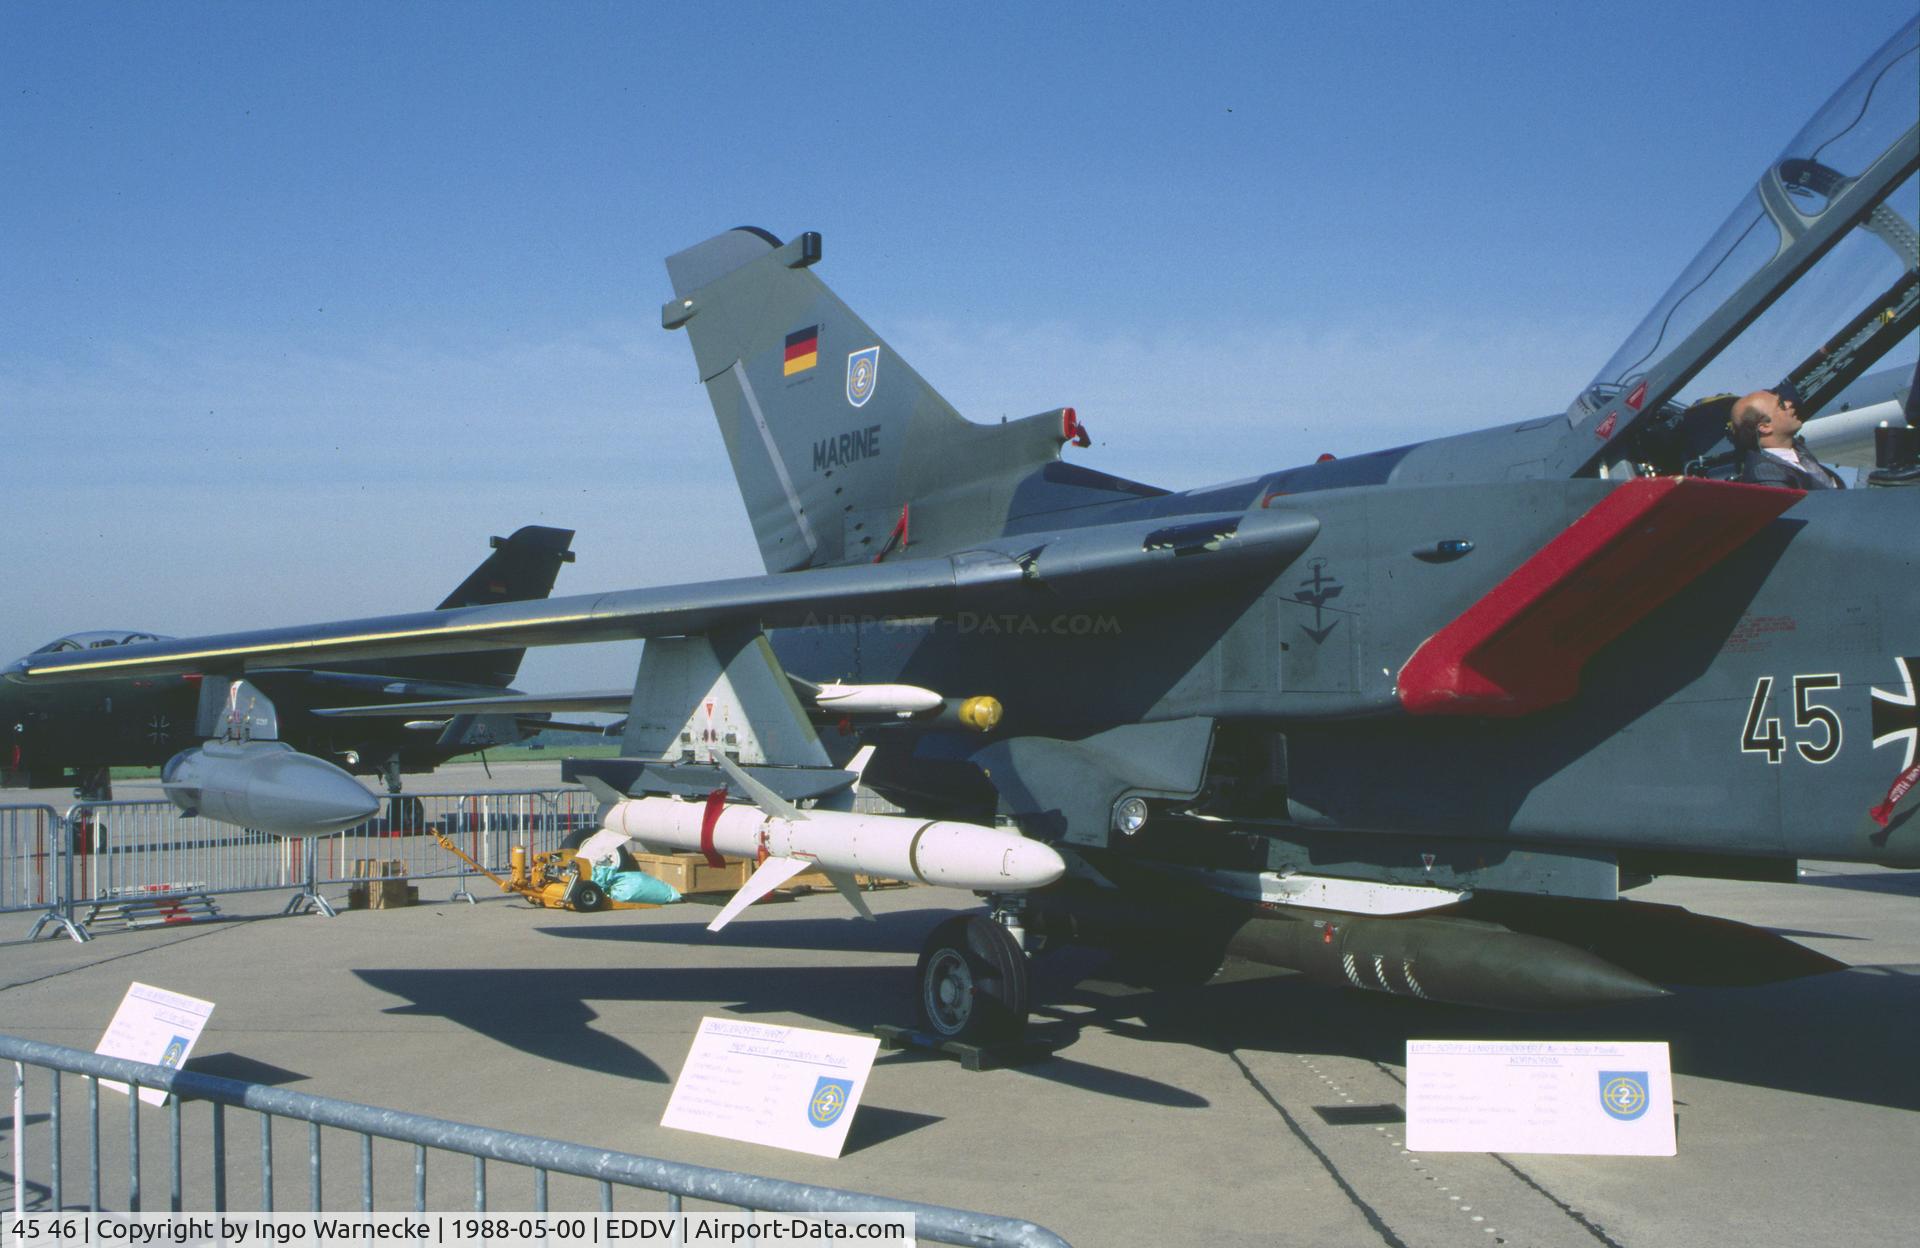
[601,755,1068,931]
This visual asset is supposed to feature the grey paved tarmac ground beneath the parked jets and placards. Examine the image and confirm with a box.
[0,764,1920,1248]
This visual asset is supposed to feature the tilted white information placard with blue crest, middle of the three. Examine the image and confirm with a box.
[660,1018,879,1158]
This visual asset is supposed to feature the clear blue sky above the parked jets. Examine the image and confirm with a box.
[0,0,1912,689]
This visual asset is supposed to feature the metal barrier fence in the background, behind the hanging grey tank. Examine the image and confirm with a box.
[0,789,597,941]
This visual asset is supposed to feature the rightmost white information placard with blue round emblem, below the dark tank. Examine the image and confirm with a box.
[1407,1041,1674,1158]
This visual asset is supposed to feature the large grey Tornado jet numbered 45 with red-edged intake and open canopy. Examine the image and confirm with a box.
[8,23,1920,1037]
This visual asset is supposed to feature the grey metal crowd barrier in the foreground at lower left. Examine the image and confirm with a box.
[0,1035,1068,1248]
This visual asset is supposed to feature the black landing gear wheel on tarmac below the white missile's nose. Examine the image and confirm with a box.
[916,914,1027,1044]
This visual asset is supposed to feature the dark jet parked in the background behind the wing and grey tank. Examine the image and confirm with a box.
[0,524,574,799]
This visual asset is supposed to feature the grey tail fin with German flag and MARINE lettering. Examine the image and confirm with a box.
[660,227,1162,572]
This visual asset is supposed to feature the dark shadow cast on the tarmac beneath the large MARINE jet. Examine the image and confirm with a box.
[357,908,1920,1110]
